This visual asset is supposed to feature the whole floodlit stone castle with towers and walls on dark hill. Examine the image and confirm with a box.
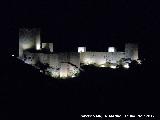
[19,28,138,78]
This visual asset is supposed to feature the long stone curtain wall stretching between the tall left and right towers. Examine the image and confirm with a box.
[24,51,125,69]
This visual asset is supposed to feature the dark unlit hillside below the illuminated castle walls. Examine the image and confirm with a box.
[5,57,159,119]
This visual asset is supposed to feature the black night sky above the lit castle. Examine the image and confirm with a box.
[4,0,160,61]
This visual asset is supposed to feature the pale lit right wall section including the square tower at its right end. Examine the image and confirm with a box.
[80,43,138,65]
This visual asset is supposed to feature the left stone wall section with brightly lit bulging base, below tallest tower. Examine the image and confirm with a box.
[22,51,80,78]
